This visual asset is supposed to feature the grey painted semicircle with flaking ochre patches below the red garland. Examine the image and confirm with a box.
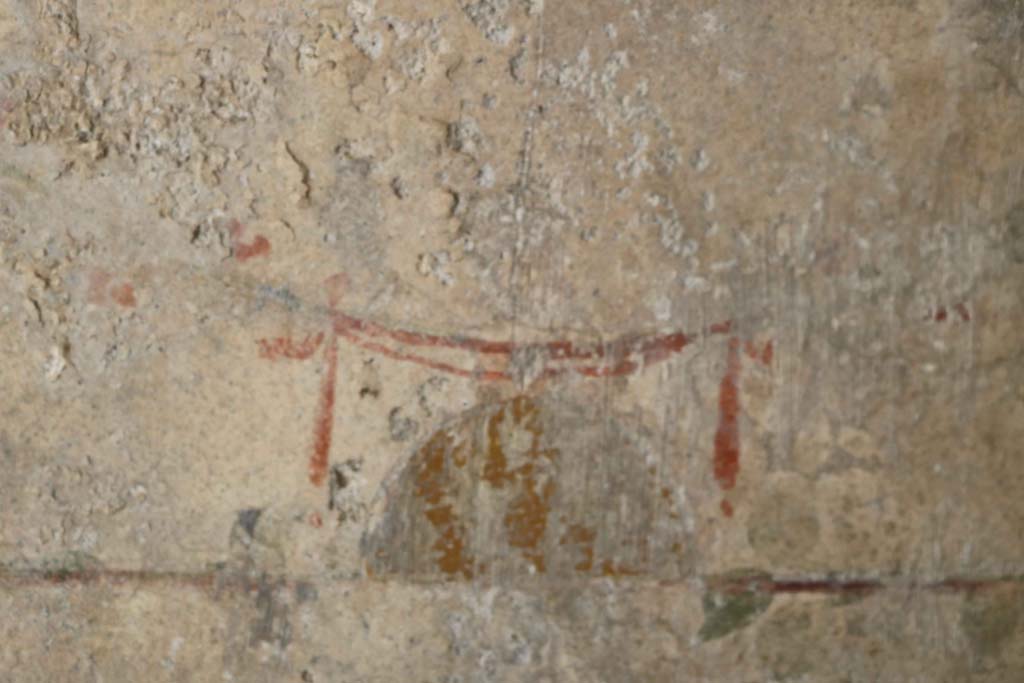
[365,396,685,581]
